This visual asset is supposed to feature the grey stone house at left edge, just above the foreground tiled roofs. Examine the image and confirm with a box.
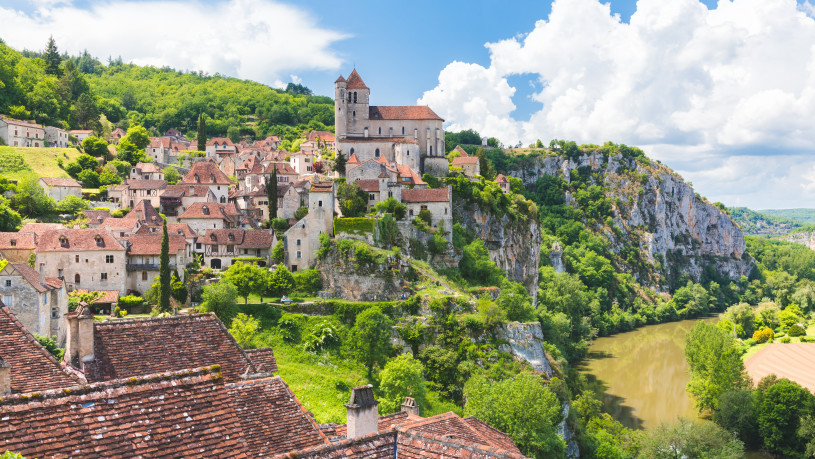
[0,263,68,346]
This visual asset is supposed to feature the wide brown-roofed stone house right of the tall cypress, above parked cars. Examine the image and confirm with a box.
[196,229,276,269]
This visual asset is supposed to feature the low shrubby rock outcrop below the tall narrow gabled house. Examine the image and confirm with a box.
[315,247,410,301]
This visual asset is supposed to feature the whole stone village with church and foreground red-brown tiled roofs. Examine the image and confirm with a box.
[0,70,522,458]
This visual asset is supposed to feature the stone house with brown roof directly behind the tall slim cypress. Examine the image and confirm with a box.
[125,232,193,294]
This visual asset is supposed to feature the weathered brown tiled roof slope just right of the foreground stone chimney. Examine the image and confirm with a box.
[85,314,257,382]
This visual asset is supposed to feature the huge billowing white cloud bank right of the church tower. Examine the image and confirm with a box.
[420,0,815,207]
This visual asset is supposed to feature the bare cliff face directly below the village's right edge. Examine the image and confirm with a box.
[460,205,541,297]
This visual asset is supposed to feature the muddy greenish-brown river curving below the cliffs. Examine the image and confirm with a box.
[579,317,717,429]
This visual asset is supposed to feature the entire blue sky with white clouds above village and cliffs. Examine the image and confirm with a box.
[0,0,815,209]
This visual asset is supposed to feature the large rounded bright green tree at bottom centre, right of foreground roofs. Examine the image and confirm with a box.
[464,373,566,457]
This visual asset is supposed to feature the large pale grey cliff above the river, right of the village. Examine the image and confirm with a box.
[508,152,753,290]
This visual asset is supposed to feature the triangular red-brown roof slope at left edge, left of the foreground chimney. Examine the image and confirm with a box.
[0,305,80,394]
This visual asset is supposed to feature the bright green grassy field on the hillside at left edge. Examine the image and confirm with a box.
[0,147,80,180]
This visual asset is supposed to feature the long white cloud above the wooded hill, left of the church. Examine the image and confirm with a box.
[0,0,346,86]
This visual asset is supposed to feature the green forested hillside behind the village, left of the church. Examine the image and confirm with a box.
[0,39,334,141]
